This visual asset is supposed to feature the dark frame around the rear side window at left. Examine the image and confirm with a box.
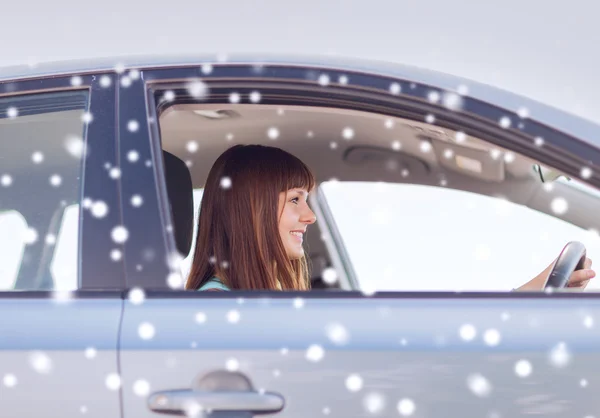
[0,71,125,290]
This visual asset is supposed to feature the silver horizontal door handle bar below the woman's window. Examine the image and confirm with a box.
[148,389,285,416]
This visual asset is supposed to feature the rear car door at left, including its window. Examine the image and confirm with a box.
[0,69,124,418]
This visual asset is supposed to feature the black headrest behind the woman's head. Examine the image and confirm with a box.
[163,151,194,257]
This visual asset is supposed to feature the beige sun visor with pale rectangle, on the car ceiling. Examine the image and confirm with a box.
[427,138,505,183]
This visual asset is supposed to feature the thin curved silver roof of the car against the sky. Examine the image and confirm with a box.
[0,54,600,148]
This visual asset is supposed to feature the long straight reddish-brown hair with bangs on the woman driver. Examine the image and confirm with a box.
[186,145,315,290]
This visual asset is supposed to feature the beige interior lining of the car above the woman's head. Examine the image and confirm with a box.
[159,103,599,288]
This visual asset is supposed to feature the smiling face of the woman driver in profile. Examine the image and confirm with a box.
[278,189,317,260]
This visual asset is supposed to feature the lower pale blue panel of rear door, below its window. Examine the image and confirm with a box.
[0,293,122,418]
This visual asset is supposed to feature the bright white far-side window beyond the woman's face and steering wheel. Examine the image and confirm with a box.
[320,181,600,291]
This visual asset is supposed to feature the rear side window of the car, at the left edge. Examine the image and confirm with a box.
[0,91,89,291]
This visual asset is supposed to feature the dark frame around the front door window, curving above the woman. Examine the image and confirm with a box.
[128,62,600,290]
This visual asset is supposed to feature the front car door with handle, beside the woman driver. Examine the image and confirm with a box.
[119,57,600,418]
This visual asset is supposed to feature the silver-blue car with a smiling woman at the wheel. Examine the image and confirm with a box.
[0,56,600,418]
